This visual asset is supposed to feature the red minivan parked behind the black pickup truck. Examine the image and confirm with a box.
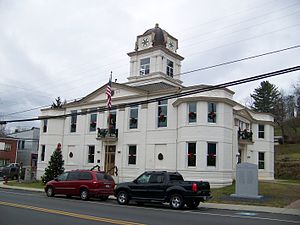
[45,170,115,201]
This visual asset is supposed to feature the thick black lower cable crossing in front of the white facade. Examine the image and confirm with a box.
[0,66,300,124]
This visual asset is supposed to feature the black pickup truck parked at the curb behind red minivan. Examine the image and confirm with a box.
[115,171,211,209]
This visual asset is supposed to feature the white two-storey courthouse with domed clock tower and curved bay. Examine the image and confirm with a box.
[38,25,274,187]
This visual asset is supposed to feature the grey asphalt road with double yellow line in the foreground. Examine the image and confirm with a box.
[0,188,300,225]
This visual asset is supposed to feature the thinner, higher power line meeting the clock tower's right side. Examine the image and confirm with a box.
[3,45,300,116]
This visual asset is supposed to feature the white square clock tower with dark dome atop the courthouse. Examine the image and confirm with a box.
[127,24,184,87]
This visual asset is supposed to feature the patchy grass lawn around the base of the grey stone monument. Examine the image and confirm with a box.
[209,180,300,208]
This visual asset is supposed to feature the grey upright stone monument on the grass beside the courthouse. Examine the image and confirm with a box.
[230,163,263,199]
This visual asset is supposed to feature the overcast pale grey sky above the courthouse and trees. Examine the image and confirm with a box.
[0,0,300,130]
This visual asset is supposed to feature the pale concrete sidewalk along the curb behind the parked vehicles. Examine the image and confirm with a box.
[0,181,300,216]
